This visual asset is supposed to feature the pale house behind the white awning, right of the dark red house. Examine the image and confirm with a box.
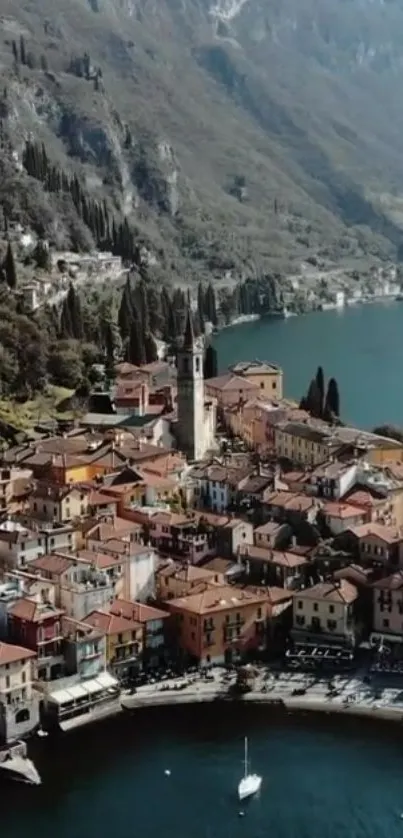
[61,617,106,681]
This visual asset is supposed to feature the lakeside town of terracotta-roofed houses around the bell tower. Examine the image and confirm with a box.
[0,310,403,779]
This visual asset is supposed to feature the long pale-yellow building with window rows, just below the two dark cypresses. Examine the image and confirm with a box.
[274,422,342,466]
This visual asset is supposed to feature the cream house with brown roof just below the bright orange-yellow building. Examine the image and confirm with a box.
[29,481,89,524]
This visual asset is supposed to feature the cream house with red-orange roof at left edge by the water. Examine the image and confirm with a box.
[0,643,39,742]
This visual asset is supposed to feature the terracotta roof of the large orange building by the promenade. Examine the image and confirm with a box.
[167,585,267,614]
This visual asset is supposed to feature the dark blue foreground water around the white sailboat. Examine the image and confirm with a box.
[0,706,403,838]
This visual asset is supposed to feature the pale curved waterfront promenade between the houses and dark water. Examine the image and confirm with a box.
[121,667,403,721]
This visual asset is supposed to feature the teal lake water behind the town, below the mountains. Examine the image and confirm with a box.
[215,302,403,429]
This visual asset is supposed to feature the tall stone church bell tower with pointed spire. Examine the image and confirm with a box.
[177,308,205,460]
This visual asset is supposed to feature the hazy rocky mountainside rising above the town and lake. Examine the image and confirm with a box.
[0,0,403,280]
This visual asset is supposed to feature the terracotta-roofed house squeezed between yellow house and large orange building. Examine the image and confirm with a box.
[110,599,170,670]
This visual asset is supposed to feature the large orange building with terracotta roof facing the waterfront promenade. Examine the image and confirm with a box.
[165,585,269,665]
